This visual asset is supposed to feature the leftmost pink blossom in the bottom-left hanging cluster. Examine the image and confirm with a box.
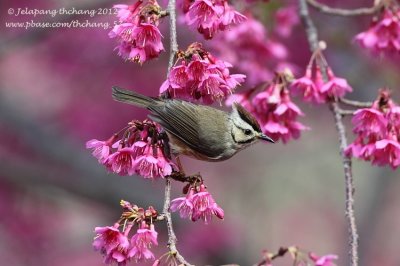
[93,224,130,265]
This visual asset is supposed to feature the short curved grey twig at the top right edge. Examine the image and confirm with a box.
[307,0,383,17]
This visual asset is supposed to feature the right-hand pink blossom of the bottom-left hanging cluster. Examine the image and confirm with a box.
[128,224,158,262]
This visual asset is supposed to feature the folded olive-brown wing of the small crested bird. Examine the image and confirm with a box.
[148,100,216,156]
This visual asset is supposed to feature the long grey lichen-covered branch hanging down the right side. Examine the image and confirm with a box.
[299,0,358,266]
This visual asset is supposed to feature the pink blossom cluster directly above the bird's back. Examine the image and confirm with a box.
[160,43,246,104]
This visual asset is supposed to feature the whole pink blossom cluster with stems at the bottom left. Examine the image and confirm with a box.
[93,200,158,266]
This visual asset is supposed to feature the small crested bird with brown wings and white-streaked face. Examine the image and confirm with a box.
[112,86,274,161]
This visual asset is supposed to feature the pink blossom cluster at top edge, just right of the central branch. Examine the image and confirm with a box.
[183,0,246,39]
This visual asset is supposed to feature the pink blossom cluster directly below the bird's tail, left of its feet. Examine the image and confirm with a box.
[86,120,174,179]
